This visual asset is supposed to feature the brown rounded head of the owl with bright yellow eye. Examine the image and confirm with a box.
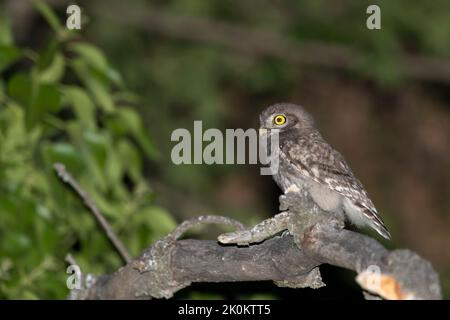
[259,103,315,131]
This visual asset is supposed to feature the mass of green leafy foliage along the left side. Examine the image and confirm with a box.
[0,3,175,299]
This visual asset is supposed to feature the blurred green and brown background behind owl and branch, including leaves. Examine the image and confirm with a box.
[0,0,450,299]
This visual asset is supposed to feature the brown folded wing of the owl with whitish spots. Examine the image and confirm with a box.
[280,138,390,239]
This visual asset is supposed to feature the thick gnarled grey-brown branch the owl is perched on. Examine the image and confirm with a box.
[71,188,441,299]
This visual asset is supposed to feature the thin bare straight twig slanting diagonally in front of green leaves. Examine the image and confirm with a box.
[53,163,132,263]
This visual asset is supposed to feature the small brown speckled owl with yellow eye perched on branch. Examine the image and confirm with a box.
[260,103,390,239]
